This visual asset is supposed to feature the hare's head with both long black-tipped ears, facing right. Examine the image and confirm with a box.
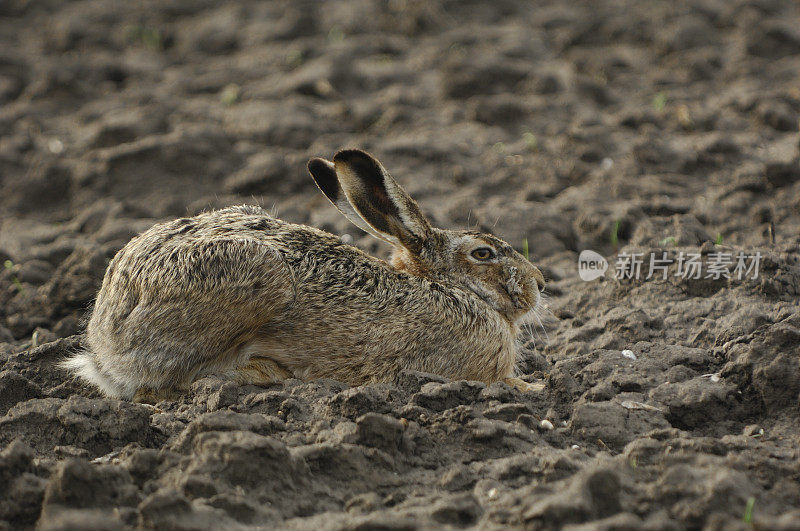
[308,149,544,323]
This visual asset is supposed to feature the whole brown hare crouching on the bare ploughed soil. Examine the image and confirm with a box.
[64,150,544,401]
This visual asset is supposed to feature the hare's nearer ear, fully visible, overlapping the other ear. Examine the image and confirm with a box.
[330,149,431,253]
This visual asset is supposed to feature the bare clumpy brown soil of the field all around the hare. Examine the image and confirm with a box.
[0,0,800,529]
